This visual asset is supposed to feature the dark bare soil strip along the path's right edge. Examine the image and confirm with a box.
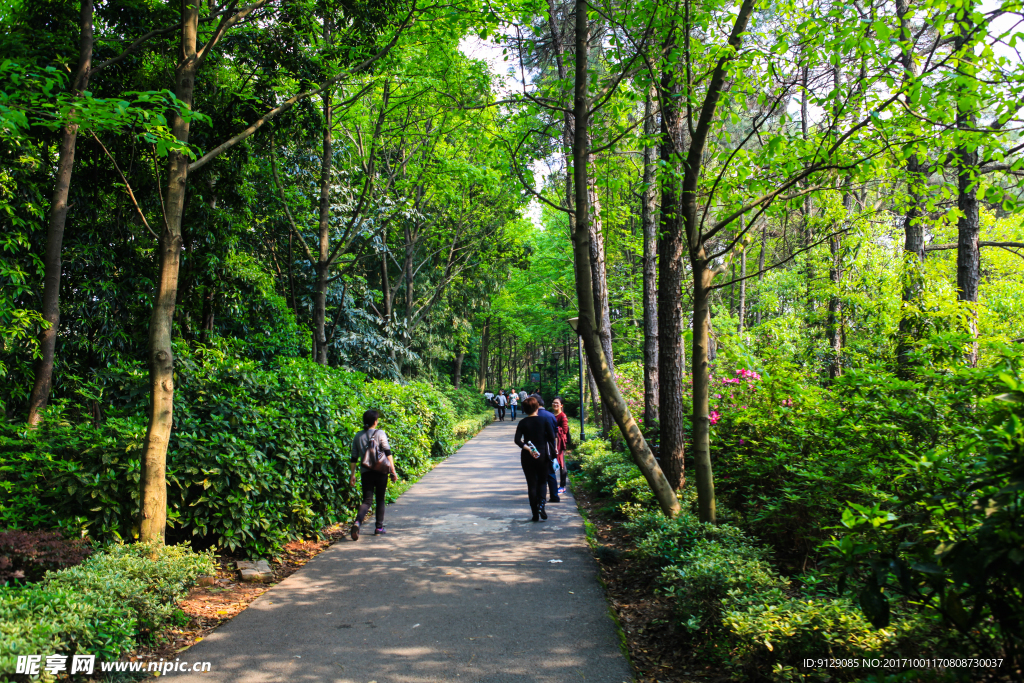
[572,485,733,683]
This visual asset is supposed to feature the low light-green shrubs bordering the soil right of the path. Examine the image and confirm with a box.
[627,512,927,681]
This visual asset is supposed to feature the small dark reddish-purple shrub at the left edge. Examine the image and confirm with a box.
[0,529,92,584]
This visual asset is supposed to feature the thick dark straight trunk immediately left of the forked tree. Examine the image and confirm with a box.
[657,41,687,489]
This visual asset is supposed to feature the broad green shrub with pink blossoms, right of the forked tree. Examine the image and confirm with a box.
[712,364,994,564]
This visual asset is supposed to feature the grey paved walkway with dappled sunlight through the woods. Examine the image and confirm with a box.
[178,421,632,683]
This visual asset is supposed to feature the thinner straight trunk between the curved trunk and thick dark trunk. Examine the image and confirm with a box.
[640,92,672,432]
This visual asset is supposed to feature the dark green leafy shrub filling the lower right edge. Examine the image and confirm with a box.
[827,362,1024,671]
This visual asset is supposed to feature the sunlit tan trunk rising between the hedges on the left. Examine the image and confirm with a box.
[139,1,199,544]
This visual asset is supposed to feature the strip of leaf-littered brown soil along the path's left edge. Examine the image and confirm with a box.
[125,524,348,661]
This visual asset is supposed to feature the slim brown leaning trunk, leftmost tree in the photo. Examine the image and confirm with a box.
[29,0,93,427]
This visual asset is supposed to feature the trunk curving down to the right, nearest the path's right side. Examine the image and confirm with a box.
[572,0,680,517]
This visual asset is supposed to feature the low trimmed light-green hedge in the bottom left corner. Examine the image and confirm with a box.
[0,544,216,680]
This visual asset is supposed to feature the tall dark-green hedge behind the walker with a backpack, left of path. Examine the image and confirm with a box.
[0,348,491,555]
